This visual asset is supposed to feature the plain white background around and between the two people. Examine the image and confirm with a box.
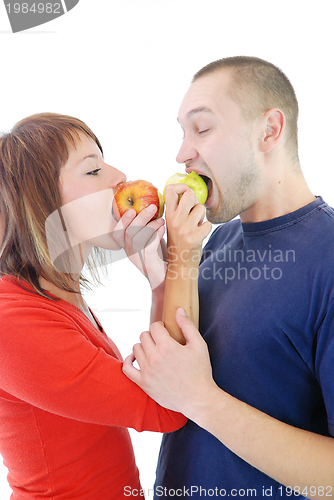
[0,0,334,500]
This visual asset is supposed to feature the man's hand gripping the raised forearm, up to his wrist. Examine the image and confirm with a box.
[123,309,217,417]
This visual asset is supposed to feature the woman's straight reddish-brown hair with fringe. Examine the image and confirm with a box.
[0,113,102,296]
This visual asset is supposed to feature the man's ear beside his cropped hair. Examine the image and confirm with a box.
[259,108,286,153]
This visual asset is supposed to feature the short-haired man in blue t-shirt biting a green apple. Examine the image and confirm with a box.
[124,57,334,498]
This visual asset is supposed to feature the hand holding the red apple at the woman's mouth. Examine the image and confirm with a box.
[113,205,167,290]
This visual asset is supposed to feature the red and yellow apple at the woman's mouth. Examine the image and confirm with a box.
[115,179,164,220]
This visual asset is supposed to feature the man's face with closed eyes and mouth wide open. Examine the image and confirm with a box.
[176,71,261,224]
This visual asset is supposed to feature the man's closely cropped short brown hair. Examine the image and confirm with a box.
[193,56,298,158]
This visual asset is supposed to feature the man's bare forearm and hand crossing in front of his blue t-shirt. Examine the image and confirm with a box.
[123,310,334,499]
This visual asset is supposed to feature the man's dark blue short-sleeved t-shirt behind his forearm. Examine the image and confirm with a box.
[155,198,334,499]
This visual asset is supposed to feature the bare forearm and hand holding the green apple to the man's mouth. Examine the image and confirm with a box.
[163,184,211,344]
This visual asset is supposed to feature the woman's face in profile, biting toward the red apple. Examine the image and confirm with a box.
[60,133,126,253]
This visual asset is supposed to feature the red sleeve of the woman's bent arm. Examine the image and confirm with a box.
[0,299,187,432]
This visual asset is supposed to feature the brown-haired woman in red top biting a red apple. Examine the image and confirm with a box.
[0,113,196,500]
